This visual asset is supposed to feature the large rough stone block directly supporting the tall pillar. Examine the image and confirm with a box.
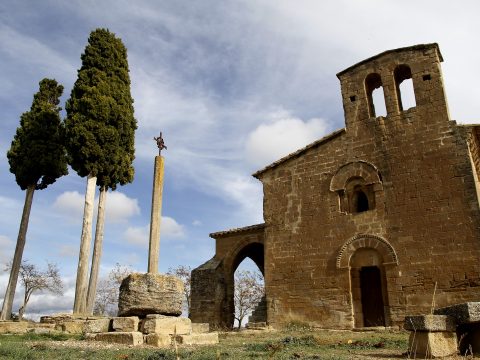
[118,273,184,317]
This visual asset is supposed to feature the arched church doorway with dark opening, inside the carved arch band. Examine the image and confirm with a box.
[349,248,388,328]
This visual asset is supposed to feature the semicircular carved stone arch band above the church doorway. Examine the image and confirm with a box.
[336,234,398,269]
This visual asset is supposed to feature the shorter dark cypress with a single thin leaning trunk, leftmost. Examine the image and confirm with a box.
[1,79,68,320]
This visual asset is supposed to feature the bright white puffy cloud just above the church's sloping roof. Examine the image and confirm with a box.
[245,114,328,167]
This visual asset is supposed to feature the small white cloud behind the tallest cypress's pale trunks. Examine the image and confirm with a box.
[53,191,140,223]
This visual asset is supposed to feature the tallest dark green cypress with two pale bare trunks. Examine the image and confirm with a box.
[66,29,137,313]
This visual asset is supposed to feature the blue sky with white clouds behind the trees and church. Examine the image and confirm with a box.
[0,0,480,313]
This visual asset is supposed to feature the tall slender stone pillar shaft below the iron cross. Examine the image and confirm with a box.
[148,156,163,274]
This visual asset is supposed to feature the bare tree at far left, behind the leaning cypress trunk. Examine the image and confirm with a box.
[5,260,63,320]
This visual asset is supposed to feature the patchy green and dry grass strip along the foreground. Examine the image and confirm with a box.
[0,327,408,360]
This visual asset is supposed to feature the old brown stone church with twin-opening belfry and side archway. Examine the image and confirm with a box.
[191,44,480,329]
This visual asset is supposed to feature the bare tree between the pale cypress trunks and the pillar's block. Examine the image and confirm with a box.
[93,263,133,316]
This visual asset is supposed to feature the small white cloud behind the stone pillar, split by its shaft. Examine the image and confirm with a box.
[124,216,185,246]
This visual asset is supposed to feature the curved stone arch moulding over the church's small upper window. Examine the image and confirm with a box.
[330,160,382,191]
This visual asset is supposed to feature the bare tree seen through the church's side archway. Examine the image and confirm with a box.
[234,270,265,329]
